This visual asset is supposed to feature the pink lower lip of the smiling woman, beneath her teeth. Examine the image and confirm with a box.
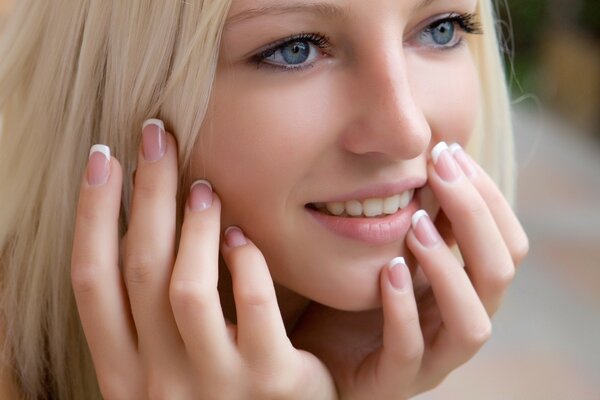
[306,196,419,245]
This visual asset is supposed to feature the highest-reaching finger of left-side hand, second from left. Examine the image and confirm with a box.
[123,120,181,365]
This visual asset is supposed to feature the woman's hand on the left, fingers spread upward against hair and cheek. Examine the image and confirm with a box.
[71,125,336,400]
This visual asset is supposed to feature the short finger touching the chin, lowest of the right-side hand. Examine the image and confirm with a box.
[377,257,424,392]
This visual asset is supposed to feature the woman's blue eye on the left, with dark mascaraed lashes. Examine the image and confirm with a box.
[252,33,329,70]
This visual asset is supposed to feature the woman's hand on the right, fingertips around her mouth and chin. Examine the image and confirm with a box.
[292,145,528,399]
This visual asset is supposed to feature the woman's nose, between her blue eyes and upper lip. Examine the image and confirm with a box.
[342,42,431,160]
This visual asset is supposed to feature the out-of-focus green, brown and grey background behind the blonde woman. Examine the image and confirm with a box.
[0,0,600,400]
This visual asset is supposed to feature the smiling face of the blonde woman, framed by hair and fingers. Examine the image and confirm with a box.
[192,0,479,310]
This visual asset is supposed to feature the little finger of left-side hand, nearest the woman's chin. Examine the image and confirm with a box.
[223,227,292,365]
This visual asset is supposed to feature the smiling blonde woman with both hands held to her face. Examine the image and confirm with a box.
[0,0,527,399]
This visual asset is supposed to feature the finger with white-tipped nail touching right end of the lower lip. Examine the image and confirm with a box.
[407,211,491,366]
